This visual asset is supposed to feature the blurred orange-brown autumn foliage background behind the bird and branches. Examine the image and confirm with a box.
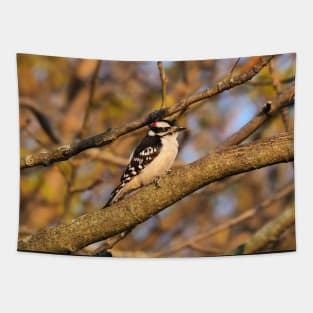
[17,54,296,256]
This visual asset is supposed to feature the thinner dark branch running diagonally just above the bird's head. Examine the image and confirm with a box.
[20,56,273,169]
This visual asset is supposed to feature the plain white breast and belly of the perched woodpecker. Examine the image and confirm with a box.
[138,133,178,185]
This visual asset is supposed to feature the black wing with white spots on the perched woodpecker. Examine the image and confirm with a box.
[106,136,162,206]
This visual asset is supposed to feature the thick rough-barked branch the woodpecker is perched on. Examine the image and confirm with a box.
[18,133,293,253]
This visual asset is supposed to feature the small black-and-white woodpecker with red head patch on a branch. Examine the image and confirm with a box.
[103,120,186,208]
